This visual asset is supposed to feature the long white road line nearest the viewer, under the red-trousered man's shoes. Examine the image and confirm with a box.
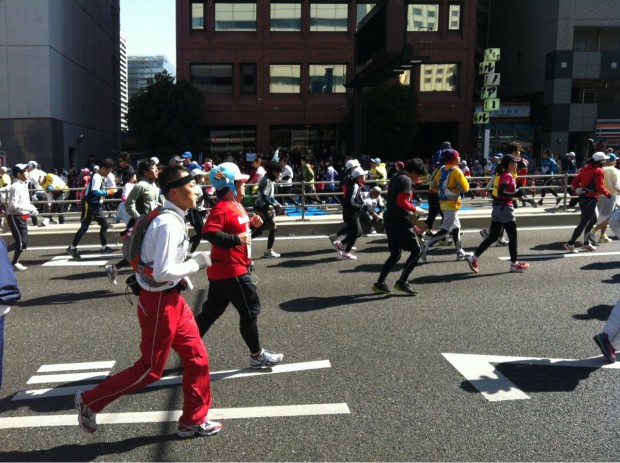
[0,403,351,429]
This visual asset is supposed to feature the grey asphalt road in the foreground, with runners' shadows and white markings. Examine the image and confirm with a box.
[0,227,620,461]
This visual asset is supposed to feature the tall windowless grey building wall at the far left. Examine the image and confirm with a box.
[0,0,121,168]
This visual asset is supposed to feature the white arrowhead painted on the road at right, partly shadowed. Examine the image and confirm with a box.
[441,353,620,402]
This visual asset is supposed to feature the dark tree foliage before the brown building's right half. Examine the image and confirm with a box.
[349,84,418,160]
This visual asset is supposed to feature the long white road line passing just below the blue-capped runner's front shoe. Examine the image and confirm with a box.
[11,360,331,400]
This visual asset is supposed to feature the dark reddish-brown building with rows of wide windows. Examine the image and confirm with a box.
[176,0,477,158]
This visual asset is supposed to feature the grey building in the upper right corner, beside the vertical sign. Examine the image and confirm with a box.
[489,0,620,162]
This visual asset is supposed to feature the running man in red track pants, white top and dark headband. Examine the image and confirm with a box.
[75,166,221,437]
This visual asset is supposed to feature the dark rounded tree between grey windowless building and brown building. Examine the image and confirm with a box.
[127,71,204,157]
